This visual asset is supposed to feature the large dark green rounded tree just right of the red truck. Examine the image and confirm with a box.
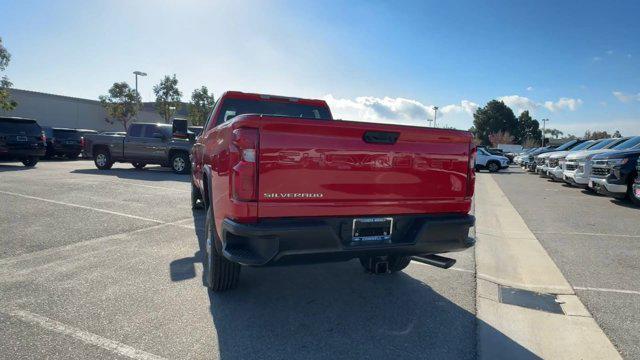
[473,100,520,145]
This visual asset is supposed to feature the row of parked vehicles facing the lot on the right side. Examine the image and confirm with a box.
[514,136,640,206]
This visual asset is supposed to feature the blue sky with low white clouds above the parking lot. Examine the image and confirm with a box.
[0,0,640,135]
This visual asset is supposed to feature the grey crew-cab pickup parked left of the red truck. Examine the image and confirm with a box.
[84,123,193,174]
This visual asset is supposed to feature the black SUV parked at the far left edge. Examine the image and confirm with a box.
[0,117,45,167]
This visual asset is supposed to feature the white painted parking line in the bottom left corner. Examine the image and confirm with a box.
[8,310,164,360]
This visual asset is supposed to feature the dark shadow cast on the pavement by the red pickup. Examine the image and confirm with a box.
[170,211,539,359]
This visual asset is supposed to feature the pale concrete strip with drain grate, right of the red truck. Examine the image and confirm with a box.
[475,174,621,359]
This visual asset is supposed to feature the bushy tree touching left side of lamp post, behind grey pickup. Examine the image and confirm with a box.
[99,82,140,131]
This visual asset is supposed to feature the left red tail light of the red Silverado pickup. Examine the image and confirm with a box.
[231,128,258,201]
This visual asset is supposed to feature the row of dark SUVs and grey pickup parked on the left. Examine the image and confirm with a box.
[0,117,202,173]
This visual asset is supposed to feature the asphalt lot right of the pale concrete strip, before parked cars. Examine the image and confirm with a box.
[492,166,640,359]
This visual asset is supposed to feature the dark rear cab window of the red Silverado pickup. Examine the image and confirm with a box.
[216,99,331,124]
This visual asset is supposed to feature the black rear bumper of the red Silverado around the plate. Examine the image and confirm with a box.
[222,215,475,266]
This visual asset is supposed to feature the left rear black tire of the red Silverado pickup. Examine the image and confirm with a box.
[204,204,240,292]
